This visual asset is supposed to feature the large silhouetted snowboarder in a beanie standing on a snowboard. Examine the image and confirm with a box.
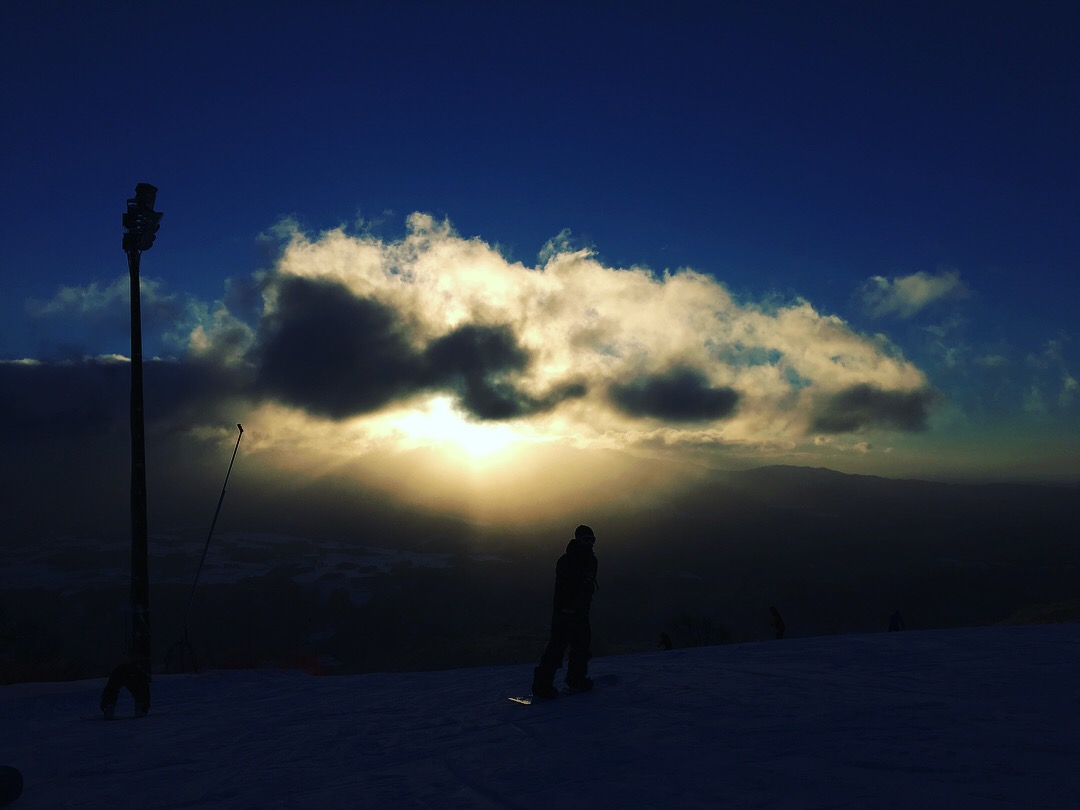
[532,526,596,698]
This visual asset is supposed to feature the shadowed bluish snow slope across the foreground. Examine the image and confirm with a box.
[0,624,1080,810]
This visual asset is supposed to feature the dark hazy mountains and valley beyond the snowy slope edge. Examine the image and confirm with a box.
[0,467,1080,680]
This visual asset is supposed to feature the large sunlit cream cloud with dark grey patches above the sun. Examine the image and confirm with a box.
[230,214,932,444]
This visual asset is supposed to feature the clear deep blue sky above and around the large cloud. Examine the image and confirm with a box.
[0,2,1080,384]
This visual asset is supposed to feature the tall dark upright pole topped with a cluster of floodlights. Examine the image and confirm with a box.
[123,183,162,677]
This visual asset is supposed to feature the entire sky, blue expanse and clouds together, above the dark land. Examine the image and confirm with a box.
[0,2,1080,494]
